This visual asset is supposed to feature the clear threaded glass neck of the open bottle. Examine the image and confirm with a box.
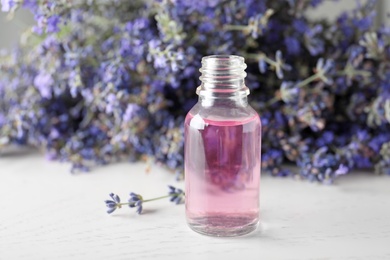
[196,55,249,106]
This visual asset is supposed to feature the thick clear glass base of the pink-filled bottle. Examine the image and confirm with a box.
[188,216,259,237]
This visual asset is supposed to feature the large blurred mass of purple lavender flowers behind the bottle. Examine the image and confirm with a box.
[0,0,390,182]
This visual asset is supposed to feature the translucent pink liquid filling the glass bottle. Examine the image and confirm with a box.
[185,111,261,236]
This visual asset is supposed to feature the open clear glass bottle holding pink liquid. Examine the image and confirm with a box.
[185,55,261,236]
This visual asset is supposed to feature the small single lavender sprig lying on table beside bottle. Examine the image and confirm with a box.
[105,185,185,214]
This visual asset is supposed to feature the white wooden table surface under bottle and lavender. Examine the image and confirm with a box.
[0,148,390,260]
